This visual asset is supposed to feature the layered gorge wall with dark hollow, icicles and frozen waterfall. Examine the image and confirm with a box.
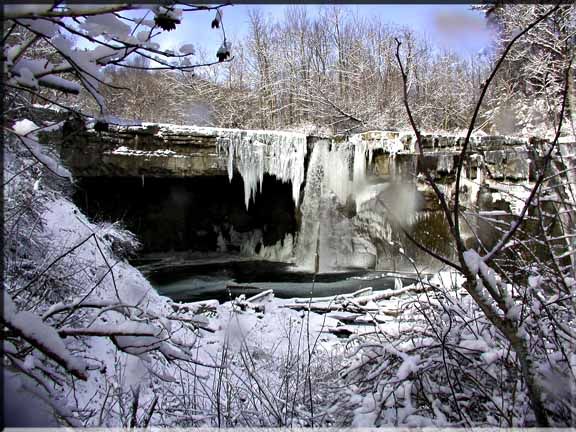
[61,122,560,270]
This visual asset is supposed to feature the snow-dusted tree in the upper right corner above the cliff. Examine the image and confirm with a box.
[482,4,576,132]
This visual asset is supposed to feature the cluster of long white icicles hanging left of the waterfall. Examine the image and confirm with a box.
[218,129,307,209]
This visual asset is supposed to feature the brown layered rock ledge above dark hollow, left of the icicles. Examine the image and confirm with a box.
[61,122,226,177]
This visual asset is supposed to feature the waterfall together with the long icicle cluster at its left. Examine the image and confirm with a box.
[218,131,424,272]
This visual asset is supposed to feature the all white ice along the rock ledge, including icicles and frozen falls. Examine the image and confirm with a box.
[210,129,526,272]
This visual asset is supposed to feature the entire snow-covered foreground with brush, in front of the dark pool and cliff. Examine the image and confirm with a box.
[2,122,576,427]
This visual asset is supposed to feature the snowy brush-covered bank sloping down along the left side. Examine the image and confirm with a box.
[2,125,220,426]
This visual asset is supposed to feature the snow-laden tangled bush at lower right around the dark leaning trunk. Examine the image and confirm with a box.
[338,274,576,427]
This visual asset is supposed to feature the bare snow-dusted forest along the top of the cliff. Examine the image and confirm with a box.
[89,6,570,134]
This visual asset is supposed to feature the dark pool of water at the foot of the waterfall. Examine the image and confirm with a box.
[147,261,415,302]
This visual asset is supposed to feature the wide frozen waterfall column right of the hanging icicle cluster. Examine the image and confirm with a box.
[294,134,415,272]
